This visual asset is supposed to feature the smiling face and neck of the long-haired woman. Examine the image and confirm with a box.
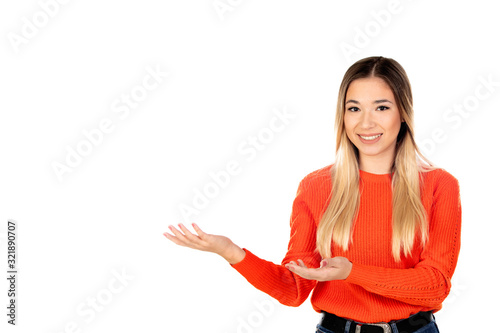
[344,77,401,169]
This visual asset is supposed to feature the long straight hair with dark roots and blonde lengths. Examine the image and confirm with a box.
[316,57,435,261]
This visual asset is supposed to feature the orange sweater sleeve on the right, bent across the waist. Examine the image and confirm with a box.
[345,171,462,308]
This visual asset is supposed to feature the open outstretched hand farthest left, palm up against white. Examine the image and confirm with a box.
[163,223,246,264]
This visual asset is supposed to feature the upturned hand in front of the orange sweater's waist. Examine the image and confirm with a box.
[285,257,352,281]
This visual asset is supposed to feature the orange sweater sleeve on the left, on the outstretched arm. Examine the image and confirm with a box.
[231,177,321,306]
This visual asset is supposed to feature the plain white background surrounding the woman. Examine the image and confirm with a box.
[0,0,500,333]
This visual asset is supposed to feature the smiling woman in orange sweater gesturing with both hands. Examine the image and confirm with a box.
[164,57,461,333]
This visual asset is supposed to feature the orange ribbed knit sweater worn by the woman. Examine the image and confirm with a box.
[231,165,461,323]
